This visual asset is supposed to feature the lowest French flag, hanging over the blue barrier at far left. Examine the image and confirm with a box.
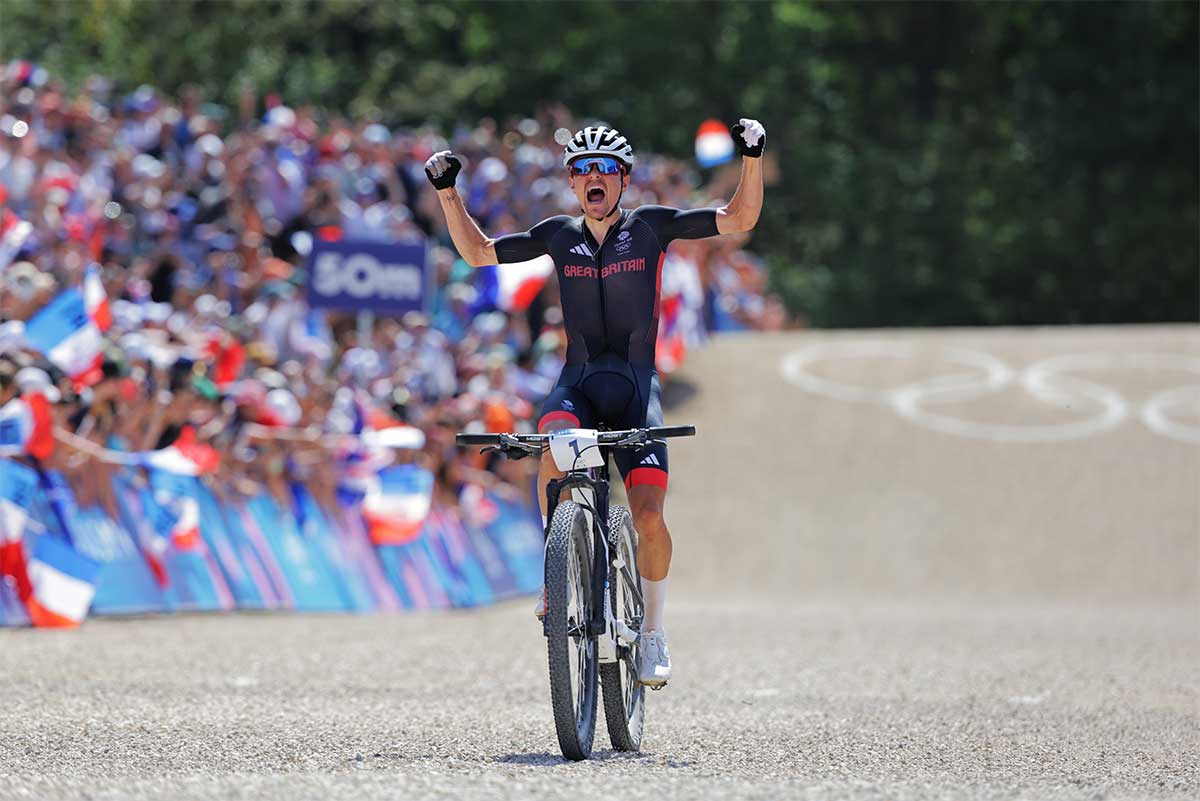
[25,535,101,628]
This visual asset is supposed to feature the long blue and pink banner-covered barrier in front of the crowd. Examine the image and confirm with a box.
[0,459,541,626]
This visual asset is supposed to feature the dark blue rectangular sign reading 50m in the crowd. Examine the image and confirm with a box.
[307,240,428,313]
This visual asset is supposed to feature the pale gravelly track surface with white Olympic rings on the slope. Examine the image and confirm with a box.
[0,327,1200,801]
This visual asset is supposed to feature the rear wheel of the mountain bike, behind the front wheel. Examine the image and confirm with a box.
[600,505,646,751]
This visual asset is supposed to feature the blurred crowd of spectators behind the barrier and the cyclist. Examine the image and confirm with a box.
[0,61,785,506]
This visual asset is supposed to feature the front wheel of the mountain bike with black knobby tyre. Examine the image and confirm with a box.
[544,500,598,760]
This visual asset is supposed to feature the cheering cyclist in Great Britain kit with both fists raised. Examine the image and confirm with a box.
[425,119,767,687]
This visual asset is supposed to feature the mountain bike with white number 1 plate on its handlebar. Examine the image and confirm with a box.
[457,426,696,760]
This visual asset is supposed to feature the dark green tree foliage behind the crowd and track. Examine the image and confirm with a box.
[0,0,1200,326]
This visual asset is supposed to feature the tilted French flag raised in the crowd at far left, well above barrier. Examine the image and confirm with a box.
[25,287,107,389]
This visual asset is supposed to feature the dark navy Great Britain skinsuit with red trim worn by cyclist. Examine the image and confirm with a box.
[496,206,719,487]
